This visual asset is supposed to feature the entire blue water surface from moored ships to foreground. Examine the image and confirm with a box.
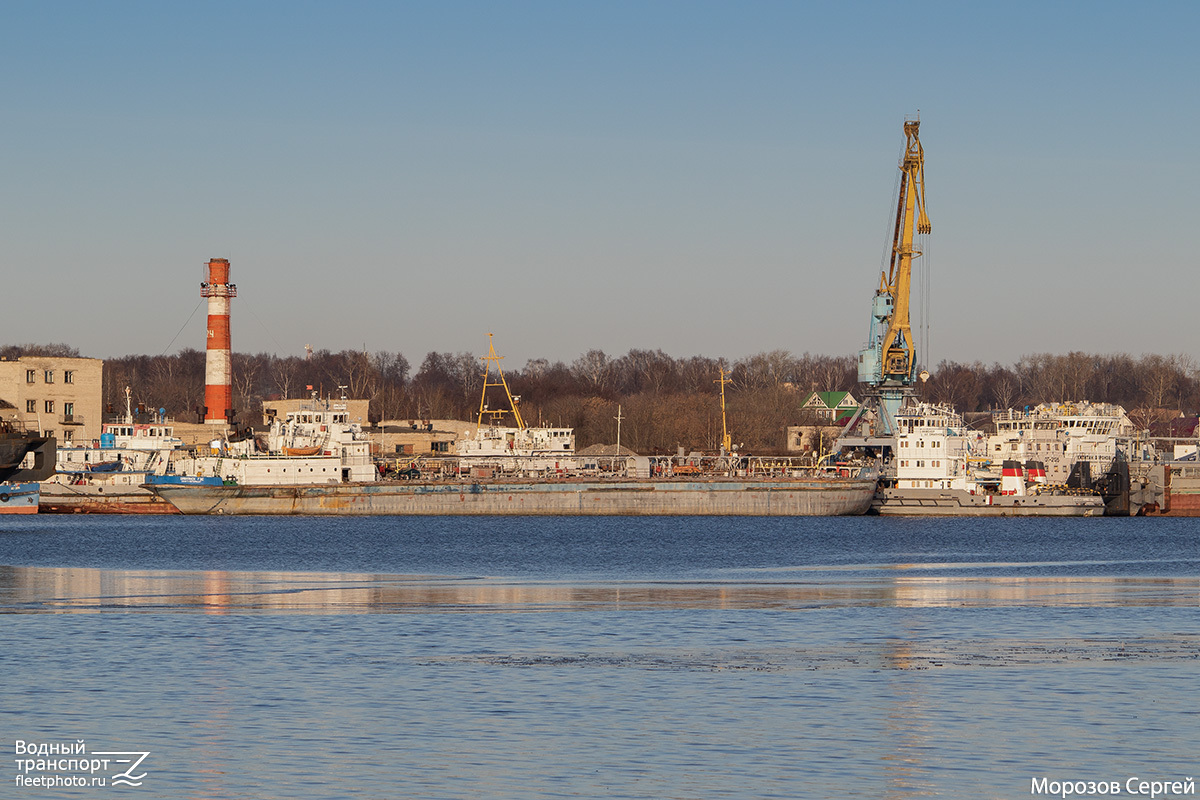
[0,516,1200,798]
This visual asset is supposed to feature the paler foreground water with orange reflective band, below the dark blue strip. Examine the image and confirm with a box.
[0,567,1200,800]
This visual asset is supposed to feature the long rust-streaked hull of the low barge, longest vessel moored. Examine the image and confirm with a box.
[152,479,875,517]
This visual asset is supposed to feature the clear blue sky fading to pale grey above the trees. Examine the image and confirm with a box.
[0,1,1200,367]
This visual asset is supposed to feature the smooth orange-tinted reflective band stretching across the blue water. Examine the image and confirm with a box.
[0,566,1200,614]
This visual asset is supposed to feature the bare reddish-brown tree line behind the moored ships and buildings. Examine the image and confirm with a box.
[0,344,1200,453]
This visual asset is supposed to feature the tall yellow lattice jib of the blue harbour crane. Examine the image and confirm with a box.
[880,120,930,384]
